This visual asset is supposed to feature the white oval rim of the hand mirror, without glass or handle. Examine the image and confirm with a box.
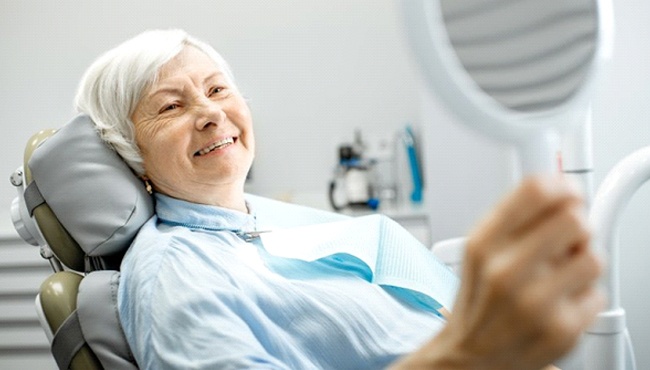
[401,0,614,144]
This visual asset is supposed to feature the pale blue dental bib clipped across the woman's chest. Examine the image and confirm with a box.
[248,196,459,312]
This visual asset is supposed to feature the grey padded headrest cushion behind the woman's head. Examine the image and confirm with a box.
[28,115,154,257]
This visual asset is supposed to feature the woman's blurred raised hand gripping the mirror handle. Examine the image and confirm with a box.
[388,177,604,370]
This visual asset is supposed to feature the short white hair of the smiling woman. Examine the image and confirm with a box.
[74,29,236,176]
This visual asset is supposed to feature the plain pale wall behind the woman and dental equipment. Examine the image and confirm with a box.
[0,0,650,369]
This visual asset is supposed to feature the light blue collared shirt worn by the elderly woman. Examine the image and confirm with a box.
[118,194,444,370]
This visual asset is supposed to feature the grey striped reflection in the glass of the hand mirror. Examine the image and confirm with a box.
[440,0,598,112]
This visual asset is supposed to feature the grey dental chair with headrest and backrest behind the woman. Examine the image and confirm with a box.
[11,115,153,370]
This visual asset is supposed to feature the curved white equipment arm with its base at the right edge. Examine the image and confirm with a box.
[585,147,650,370]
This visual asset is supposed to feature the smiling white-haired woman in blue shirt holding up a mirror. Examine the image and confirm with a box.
[76,30,603,370]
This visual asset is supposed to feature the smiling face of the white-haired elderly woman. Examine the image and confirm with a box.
[131,46,255,205]
